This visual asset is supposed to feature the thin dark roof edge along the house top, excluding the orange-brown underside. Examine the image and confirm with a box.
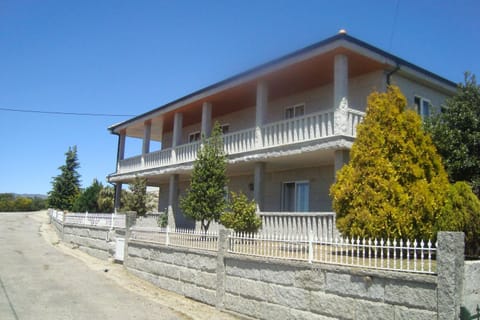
[108,32,457,133]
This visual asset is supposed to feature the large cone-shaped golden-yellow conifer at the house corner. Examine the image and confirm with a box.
[330,86,449,239]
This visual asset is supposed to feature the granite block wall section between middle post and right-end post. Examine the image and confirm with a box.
[224,255,437,320]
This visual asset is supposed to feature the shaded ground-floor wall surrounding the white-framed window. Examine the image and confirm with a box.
[263,165,334,212]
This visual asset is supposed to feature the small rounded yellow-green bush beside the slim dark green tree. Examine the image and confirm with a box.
[220,192,262,233]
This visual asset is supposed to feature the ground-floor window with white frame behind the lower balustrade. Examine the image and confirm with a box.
[282,181,310,212]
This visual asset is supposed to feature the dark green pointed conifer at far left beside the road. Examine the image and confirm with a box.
[48,146,80,211]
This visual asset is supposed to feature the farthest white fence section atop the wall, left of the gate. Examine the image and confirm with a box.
[49,209,125,229]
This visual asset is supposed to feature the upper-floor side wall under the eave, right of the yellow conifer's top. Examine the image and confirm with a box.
[391,74,449,112]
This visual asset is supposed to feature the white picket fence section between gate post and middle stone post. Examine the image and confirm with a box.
[131,226,218,251]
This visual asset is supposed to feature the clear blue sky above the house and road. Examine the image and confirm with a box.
[0,0,480,194]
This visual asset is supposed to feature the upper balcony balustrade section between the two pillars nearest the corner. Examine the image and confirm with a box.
[262,111,333,147]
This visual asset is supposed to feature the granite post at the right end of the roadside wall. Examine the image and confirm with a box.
[437,232,465,320]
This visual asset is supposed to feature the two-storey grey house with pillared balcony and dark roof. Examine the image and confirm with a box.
[108,31,456,227]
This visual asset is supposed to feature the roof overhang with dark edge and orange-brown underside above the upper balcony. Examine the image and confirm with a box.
[109,33,456,140]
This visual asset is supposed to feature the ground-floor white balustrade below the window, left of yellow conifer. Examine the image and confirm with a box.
[260,212,338,240]
